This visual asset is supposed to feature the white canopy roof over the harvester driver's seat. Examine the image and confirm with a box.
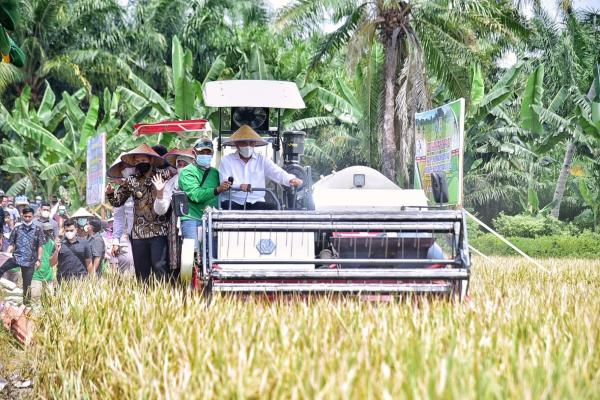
[204,80,306,109]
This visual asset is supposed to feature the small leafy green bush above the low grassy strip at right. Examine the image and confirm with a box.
[493,214,565,238]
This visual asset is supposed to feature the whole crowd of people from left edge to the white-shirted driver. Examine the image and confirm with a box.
[0,125,302,303]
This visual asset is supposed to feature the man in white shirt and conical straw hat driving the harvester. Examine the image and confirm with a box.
[219,125,302,210]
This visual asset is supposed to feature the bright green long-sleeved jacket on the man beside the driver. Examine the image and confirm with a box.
[179,163,220,221]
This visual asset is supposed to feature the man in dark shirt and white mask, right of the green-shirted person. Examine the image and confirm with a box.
[50,219,92,284]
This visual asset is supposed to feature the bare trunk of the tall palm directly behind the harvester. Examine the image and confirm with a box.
[381,28,400,182]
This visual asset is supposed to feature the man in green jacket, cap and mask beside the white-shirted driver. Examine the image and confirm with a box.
[179,138,231,241]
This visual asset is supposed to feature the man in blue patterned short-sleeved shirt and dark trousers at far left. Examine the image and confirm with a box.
[0,207,45,304]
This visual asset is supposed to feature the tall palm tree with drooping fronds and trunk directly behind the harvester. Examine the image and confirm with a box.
[278,0,526,181]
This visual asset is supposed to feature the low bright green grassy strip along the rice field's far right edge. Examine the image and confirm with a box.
[469,232,600,259]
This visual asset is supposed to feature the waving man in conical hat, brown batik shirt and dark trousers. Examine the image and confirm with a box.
[106,144,169,282]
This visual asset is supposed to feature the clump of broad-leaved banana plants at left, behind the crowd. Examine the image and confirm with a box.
[0,83,145,207]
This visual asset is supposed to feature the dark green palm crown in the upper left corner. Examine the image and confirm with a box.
[0,0,129,104]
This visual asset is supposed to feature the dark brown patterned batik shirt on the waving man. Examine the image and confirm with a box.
[106,174,169,239]
